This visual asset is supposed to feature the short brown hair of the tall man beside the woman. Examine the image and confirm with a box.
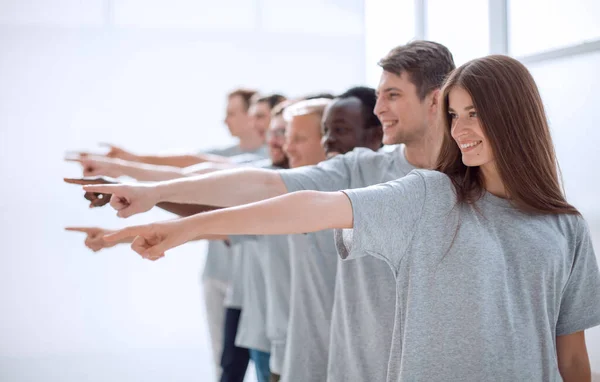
[378,40,456,100]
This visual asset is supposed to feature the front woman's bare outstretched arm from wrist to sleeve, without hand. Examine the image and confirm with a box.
[184,191,352,235]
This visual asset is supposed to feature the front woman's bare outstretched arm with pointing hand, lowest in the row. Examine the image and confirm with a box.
[105,191,353,260]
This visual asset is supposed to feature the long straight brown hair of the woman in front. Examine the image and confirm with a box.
[436,55,579,214]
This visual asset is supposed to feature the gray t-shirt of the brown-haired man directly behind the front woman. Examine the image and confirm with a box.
[280,146,414,382]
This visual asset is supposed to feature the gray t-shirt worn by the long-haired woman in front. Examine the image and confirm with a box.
[336,170,600,381]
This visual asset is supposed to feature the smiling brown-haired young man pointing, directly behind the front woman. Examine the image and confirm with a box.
[83,41,454,381]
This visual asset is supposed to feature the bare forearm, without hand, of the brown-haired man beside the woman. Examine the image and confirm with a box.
[156,168,287,207]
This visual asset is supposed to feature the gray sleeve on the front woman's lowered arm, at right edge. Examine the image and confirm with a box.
[556,218,600,336]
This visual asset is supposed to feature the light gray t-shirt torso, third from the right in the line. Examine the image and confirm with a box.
[281,230,337,382]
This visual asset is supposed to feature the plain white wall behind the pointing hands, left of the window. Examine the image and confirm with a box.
[0,0,365,382]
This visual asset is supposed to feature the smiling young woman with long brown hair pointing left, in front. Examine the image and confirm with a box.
[91,56,600,381]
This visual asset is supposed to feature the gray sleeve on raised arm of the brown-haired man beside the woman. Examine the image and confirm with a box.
[279,148,381,192]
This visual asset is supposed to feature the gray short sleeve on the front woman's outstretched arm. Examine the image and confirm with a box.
[334,171,426,267]
